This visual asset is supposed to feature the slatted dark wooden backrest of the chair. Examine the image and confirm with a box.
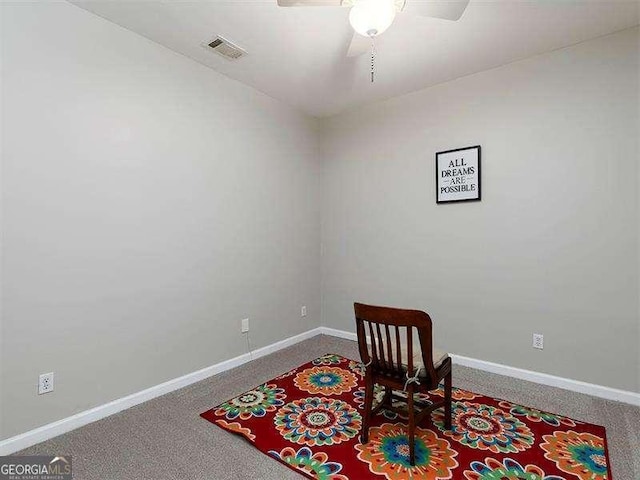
[353,303,436,381]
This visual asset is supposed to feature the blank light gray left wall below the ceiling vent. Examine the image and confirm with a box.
[0,2,321,439]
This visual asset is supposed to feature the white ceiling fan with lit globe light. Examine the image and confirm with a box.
[278,0,469,57]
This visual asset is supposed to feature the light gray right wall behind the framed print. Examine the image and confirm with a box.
[322,28,640,392]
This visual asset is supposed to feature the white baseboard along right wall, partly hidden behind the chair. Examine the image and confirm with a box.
[320,327,640,406]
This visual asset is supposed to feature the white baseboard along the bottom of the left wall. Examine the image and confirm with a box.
[0,328,322,455]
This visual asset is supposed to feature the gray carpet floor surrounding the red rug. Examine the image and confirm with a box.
[19,336,640,480]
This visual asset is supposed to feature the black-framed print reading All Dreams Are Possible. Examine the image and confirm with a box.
[436,145,480,203]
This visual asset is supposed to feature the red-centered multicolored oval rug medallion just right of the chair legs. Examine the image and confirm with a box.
[431,402,534,453]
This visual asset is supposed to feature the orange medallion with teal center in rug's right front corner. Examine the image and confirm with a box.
[540,430,607,480]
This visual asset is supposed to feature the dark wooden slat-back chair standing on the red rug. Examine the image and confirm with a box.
[354,303,451,465]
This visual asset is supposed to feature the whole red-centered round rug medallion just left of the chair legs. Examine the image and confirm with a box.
[274,397,362,447]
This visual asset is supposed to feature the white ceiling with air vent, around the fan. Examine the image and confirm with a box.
[72,0,639,117]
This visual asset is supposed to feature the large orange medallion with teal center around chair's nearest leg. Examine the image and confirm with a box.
[355,423,458,480]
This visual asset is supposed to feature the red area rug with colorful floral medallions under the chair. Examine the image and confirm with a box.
[201,354,611,480]
